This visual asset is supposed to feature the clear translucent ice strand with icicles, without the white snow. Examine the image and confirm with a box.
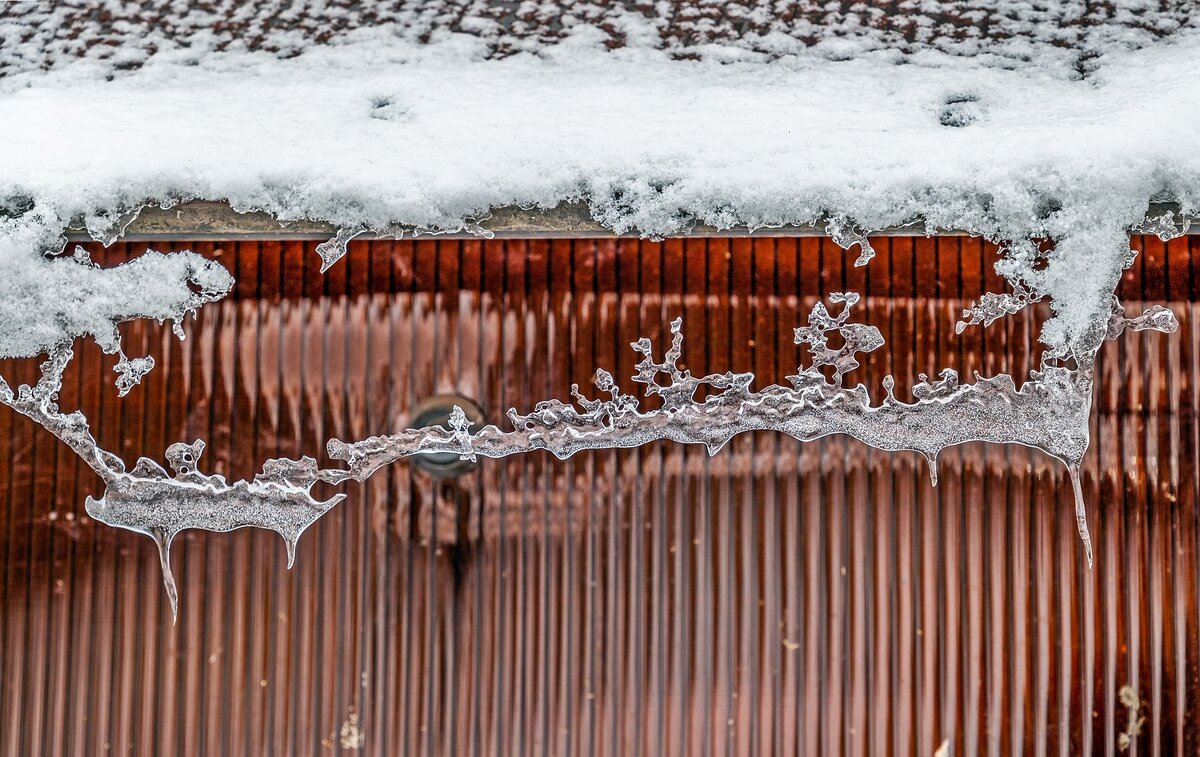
[0,227,1178,615]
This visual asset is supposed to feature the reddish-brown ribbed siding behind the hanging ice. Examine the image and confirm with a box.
[0,236,1200,756]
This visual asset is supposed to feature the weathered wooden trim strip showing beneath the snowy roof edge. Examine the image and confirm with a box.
[67,200,1200,241]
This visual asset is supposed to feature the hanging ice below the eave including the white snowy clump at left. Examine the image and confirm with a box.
[0,197,1183,613]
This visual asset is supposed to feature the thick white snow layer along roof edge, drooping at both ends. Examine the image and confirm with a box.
[0,17,1200,355]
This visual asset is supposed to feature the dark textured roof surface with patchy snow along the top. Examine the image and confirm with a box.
[0,0,1194,77]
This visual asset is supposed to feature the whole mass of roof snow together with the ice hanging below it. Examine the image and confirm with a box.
[0,0,1200,608]
